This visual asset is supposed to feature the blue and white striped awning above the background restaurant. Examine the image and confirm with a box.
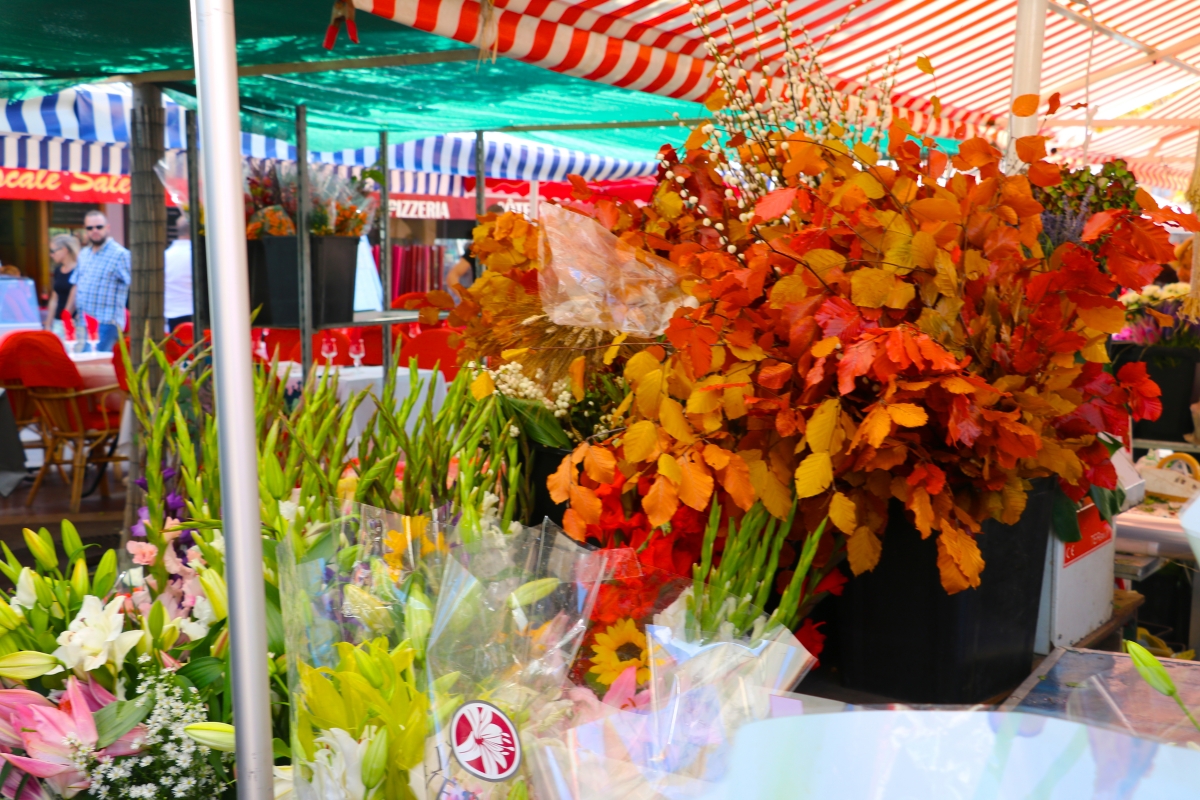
[0,86,658,181]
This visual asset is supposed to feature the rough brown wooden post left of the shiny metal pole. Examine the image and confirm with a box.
[128,84,167,367]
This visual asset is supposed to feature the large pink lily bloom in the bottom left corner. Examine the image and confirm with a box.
[2,678,139,798]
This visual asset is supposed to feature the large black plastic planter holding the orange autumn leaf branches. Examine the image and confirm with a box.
[835,480,1057,703]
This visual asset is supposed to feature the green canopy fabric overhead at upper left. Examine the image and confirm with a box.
[0,0,707,154]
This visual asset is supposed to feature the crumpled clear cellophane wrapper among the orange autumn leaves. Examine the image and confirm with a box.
[539,204,688,337]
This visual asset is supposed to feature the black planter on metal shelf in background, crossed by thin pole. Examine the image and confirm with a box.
[246,236,359,327]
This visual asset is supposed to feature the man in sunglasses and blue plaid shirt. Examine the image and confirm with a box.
[71,211,132,353]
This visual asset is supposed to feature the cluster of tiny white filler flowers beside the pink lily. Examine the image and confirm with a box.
[86,672,224,800]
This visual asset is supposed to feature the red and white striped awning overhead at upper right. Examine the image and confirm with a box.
[355,0,1200,194]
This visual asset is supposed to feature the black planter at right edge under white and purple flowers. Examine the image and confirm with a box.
[1112,343,1200,441]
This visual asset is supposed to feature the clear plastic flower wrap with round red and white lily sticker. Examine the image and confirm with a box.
[424,528,605,800]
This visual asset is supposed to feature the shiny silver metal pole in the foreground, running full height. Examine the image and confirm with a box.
[191,0,274,800]
